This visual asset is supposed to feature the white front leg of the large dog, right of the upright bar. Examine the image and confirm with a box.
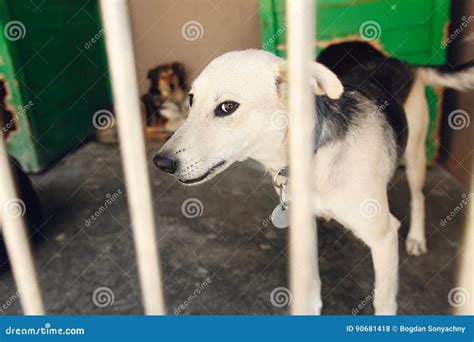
[369,214,400,315]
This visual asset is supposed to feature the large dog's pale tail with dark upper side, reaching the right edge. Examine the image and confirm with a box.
[418,61,474,90]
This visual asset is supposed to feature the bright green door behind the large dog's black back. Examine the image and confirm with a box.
[260,0,450,162]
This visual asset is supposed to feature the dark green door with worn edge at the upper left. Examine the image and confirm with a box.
[0,0,111,172]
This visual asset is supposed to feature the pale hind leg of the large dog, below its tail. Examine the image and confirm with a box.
[405,82,429,255]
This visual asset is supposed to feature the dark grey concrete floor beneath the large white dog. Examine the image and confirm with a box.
[0,143,465,315]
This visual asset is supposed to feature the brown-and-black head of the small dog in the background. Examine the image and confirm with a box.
[148,62,185,99]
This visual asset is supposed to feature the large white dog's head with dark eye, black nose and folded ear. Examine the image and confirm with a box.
[154,50,343,185]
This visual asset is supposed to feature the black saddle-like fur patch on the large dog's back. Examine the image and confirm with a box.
[318,42,416,157]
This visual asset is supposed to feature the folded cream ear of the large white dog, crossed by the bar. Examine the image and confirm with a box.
[277,62,344,99]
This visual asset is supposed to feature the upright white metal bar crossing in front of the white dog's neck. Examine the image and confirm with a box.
[286,0,319,315]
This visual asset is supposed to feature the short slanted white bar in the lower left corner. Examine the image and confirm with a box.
[0,136,44,315]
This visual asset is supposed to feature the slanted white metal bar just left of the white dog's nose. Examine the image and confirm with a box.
[101,0,165,315]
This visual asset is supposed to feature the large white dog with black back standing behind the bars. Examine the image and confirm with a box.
[154,43,474,314]
